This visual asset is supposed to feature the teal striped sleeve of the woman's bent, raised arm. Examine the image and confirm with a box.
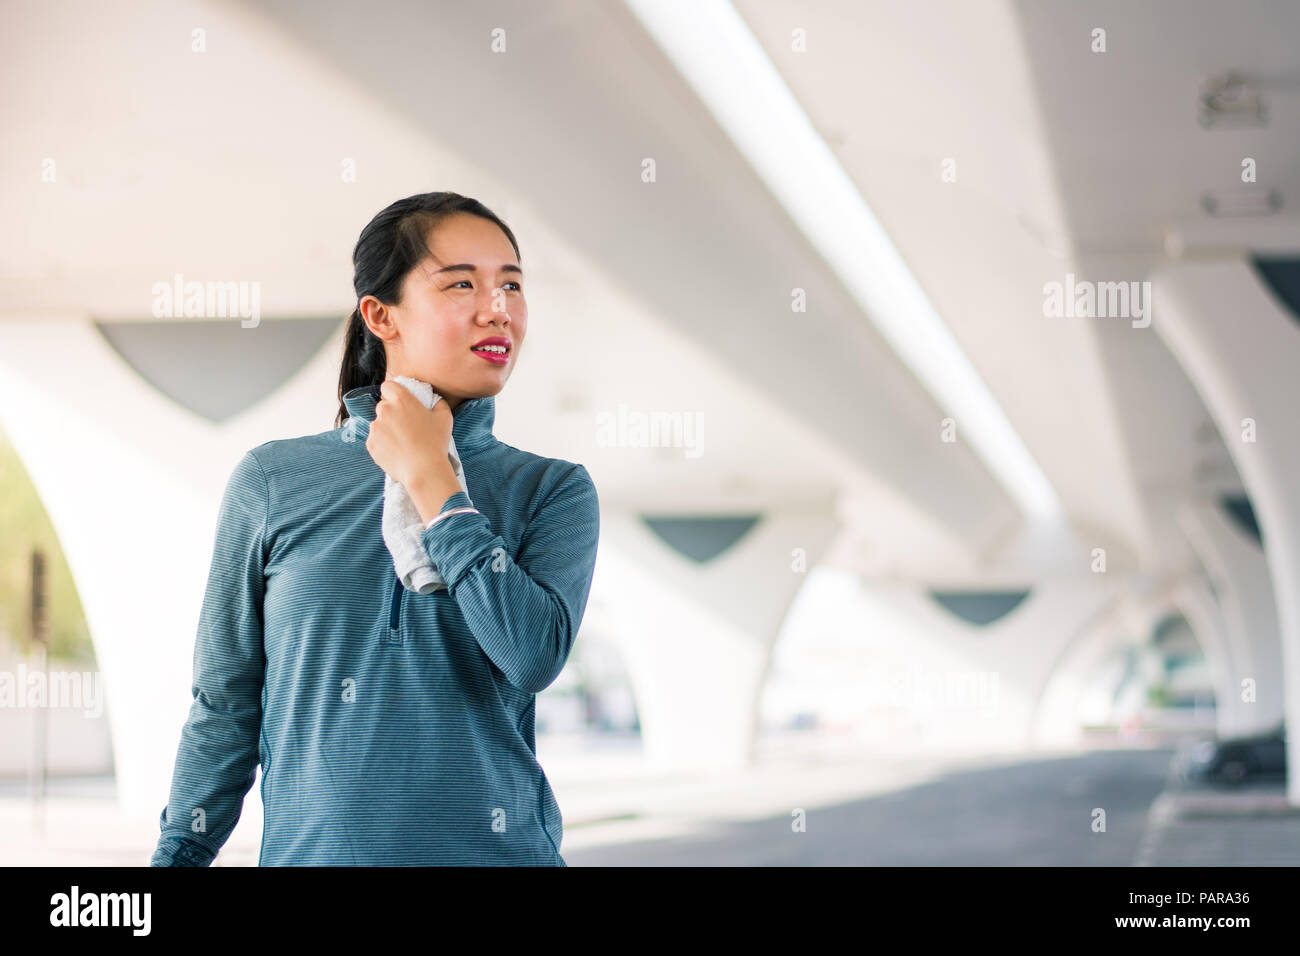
[421,464,601,693]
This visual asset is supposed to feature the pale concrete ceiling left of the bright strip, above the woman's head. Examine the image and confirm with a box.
[0,0,1018,570]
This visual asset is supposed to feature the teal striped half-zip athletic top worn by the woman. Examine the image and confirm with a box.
[151,386,599,866]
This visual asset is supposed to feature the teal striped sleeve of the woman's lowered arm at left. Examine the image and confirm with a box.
[150,451,270,866]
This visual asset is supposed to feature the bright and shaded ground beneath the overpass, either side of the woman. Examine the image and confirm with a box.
[0,732,1300,866]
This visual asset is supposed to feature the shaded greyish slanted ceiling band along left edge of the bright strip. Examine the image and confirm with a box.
[245,0,1019,564]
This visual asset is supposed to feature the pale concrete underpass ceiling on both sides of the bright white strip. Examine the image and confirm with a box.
[10,0,1274,574]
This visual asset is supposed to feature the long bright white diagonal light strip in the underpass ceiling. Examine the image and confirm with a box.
[624,0,1062,519]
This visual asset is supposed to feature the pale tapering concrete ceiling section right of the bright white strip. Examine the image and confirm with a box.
[740,0,1159,567]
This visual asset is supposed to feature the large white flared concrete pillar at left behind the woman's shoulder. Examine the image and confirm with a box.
[0,315,341,822]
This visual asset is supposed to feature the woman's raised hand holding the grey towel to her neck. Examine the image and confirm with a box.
[365,378,460,522]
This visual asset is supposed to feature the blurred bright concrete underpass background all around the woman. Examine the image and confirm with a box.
[0,0,1300,866]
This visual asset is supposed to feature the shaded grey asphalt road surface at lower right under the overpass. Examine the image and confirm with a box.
[563,749,1173,866]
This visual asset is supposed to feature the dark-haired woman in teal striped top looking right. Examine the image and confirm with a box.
[151,193,599,866]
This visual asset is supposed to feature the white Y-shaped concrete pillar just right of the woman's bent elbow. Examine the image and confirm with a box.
[593,503,839,773]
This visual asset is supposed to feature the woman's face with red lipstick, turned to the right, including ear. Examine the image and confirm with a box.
[361,213,528,408]
